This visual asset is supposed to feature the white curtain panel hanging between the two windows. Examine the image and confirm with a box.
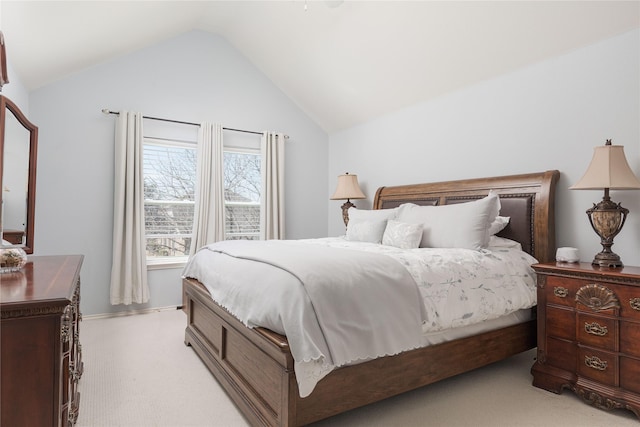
[189,123,224,255]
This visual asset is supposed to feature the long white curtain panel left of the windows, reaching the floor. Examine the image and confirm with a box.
[110,111,149,305]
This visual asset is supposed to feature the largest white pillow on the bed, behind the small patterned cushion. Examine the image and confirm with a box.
[398,193,500,250]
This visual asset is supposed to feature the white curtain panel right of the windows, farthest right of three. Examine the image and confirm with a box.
[260,132,285,240]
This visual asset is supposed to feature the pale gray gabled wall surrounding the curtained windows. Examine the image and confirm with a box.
[25,31,328,315]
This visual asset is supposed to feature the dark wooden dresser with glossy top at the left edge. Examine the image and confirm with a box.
[0,255,83,427]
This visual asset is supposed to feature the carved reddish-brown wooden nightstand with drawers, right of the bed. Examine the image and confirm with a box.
[531,263,640,418]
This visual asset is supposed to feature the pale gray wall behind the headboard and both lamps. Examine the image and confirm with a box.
[327,30,640,265]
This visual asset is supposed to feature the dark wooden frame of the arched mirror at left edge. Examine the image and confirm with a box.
[0,94,38,254]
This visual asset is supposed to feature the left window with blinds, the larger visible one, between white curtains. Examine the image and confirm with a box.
[143,138,196,262]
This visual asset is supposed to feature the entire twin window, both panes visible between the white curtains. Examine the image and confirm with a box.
[143,138,262,264]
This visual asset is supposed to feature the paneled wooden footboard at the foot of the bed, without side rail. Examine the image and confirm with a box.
[183,279,298,426]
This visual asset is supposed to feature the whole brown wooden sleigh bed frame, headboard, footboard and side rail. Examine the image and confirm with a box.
[183,171,559,426]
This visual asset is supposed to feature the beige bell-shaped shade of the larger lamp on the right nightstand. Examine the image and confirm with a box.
[569,144,640,190]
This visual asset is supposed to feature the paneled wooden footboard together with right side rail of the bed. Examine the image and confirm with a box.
[183,279,536,426]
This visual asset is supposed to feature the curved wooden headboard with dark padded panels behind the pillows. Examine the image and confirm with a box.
[373,170,560,262]
